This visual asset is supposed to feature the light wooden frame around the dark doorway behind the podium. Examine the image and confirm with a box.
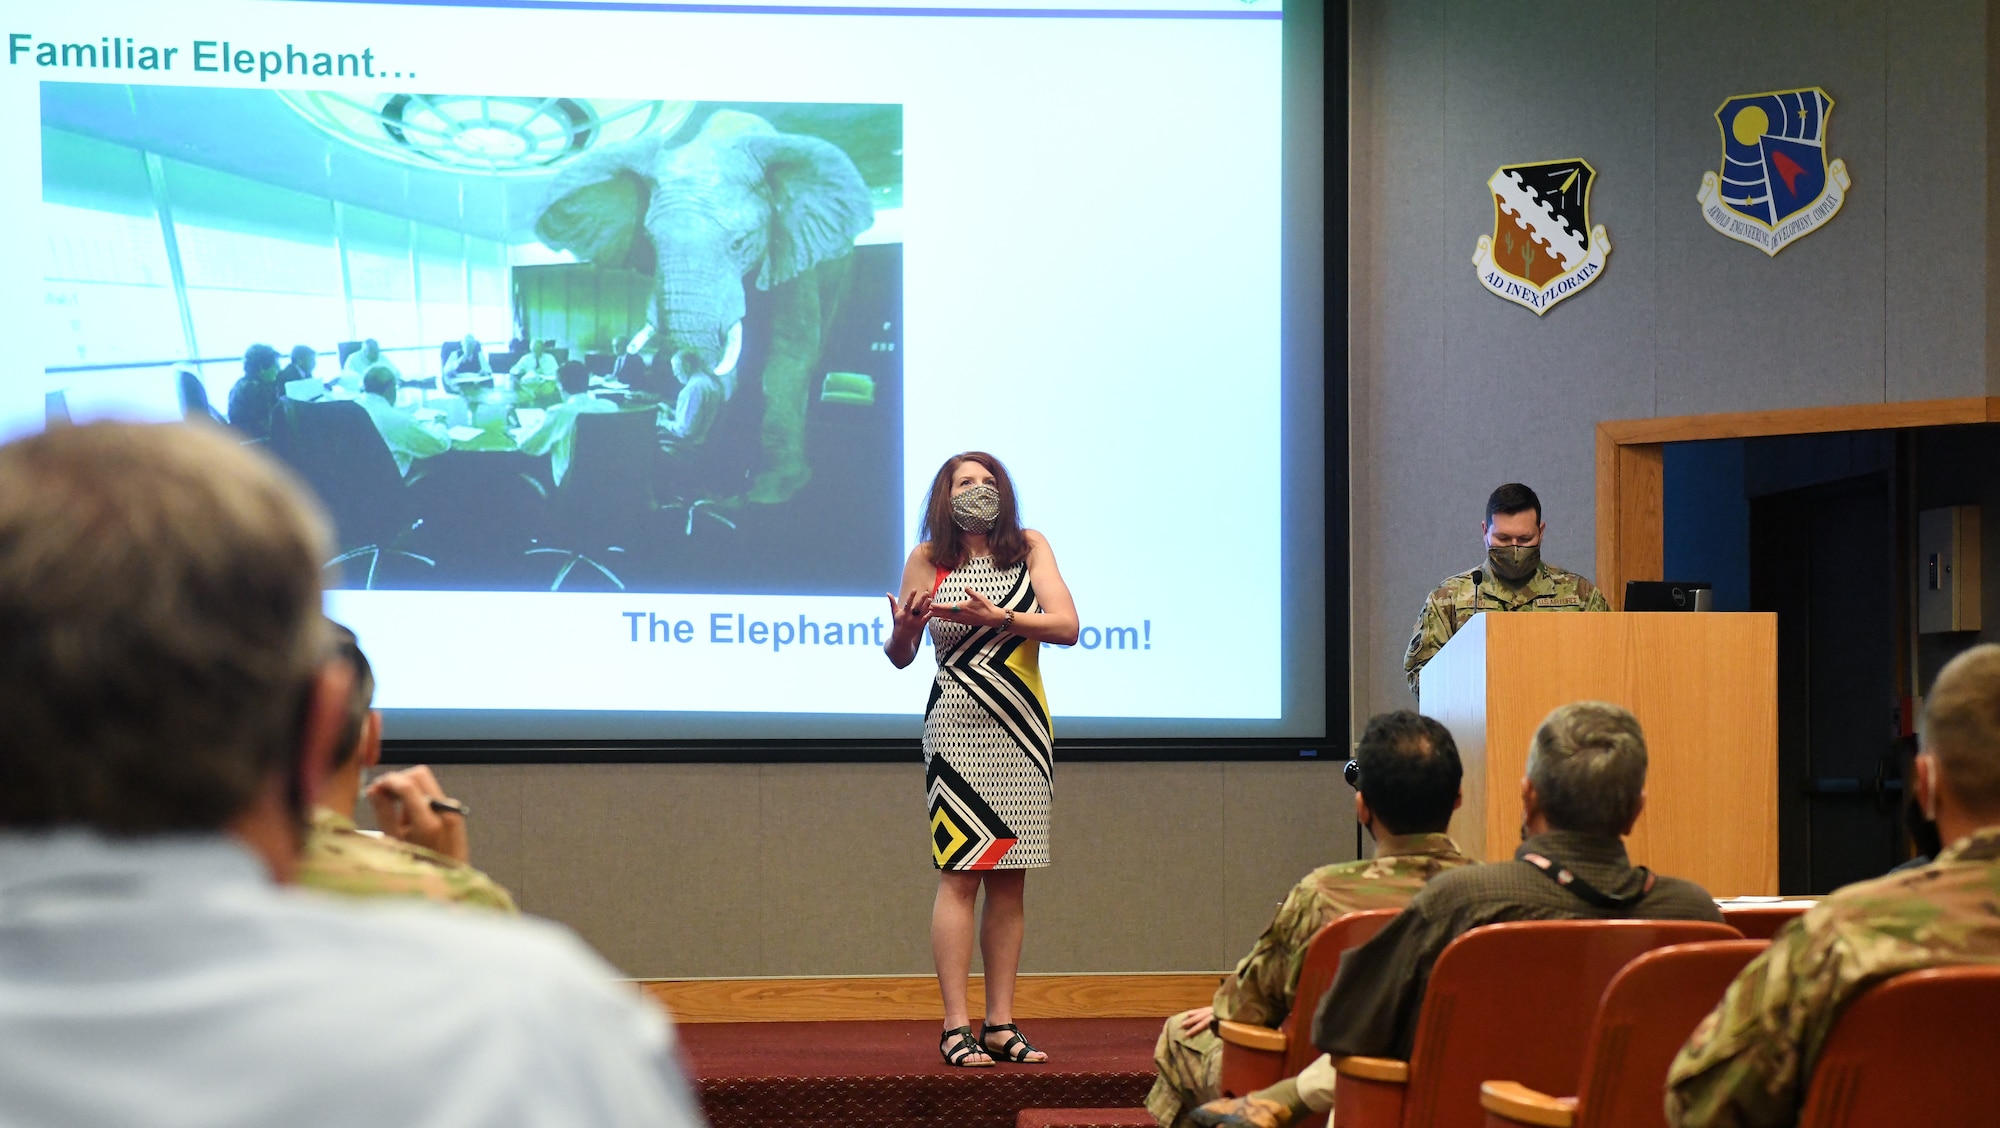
[1596,396,2000,610]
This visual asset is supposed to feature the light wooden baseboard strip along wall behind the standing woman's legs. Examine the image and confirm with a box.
[636,972,1224,1022]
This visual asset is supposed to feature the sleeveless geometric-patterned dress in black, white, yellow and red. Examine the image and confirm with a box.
[924,556,1056,870]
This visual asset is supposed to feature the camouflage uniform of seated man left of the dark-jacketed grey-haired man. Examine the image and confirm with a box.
[1146,834,1472,1128]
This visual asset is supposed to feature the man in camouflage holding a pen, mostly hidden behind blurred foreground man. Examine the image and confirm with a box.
[296,624,516,912]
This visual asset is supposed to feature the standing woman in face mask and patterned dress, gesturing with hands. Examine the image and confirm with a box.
[886,450,1076,1066]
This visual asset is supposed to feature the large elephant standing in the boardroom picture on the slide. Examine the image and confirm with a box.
[534,110,874,504]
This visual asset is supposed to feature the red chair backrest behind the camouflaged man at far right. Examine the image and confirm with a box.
[1798,964,2000,1128]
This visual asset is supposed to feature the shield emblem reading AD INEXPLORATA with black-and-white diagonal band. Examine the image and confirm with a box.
[1472,158,1612,316]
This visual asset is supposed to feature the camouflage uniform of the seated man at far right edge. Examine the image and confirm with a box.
[1666,826,2000,1128]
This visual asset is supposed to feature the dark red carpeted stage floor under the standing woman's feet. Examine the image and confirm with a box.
[680,1018,1164,1128]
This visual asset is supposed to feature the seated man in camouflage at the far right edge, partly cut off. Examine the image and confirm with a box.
[1666,644,2000,1128]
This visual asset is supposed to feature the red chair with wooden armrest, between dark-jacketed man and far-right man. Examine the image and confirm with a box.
[1480,940,1770,1128]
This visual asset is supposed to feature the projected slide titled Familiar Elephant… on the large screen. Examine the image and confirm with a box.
[0,0,1326,742]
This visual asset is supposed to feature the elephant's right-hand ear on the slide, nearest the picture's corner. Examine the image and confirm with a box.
[742,134,874,290]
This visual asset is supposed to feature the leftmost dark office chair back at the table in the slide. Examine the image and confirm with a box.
[270,400,408,548]
